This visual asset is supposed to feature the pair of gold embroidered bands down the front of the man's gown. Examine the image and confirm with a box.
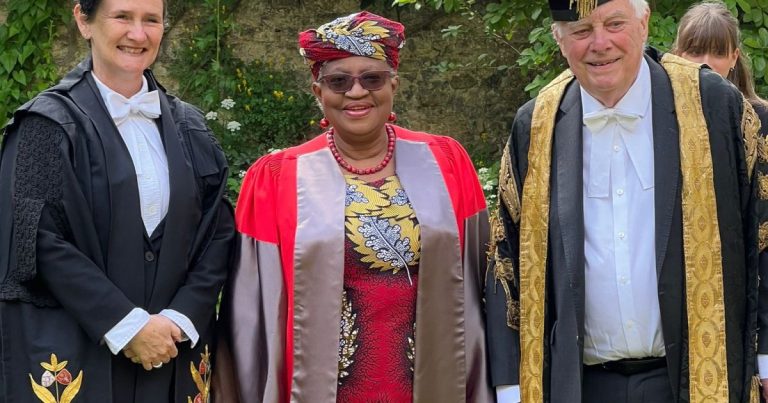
[520,55,728,403]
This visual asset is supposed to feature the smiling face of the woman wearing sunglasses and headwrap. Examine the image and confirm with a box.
[312,56,399,142]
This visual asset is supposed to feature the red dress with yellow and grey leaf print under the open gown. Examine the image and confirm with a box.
[337,176,420,402]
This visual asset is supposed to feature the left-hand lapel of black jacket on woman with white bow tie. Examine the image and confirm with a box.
[70,66,145,306]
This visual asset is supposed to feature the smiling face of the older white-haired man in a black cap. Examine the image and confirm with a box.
[553,0,649,107]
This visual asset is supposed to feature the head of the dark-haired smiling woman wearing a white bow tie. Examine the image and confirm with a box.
[74,0,164,96]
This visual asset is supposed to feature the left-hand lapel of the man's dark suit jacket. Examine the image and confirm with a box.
[553,80,584,329]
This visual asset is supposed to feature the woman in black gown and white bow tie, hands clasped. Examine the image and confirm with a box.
[0,0,235,403]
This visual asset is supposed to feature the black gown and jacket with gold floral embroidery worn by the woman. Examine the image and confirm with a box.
[0,59,235,403]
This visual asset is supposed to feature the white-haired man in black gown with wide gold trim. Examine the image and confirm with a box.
[485,0,768,403]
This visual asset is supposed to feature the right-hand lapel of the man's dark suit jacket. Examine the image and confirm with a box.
[646,53,680,276]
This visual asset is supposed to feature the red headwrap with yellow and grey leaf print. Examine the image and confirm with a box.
[299,11,405,79]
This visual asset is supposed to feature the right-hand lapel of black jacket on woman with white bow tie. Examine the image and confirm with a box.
[147,84,201,309]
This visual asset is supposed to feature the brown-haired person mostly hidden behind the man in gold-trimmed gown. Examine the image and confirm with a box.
[672,1,768,399]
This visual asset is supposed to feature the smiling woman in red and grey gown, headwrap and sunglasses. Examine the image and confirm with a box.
[216,12,493,403]
